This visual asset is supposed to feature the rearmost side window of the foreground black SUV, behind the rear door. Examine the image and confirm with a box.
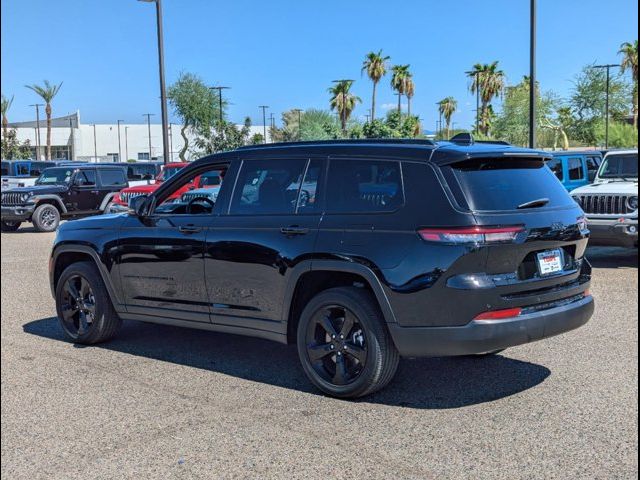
[327,159,404,213]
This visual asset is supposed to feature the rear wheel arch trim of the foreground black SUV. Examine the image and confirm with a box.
[283,260,396,343]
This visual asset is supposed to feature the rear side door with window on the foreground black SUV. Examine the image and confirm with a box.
[205,157,325,330]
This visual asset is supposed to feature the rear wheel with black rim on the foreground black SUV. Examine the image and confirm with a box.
[297,287,400,398]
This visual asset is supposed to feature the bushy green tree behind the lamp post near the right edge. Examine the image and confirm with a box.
[569,65,629,145]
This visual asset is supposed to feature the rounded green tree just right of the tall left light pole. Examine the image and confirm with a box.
[167,73,219,162]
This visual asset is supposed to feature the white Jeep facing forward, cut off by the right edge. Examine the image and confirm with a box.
[571,149,638,248]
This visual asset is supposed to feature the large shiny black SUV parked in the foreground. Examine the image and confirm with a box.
[50,140,594,397]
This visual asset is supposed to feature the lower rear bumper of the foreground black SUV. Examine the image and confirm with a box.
[388,296,594,357]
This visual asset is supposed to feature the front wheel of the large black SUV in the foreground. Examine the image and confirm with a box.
[56,262,122,345]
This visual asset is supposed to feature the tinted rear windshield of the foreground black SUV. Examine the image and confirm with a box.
[450,158,573,211]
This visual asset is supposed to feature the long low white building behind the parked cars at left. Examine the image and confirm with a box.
[9,112,269,162]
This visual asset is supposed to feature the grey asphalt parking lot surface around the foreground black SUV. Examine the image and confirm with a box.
[1,228,638,479]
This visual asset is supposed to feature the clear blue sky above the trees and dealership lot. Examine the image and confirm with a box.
[1,0,638,129]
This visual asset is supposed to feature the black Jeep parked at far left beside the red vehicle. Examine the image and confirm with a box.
[2,164,127,232]
